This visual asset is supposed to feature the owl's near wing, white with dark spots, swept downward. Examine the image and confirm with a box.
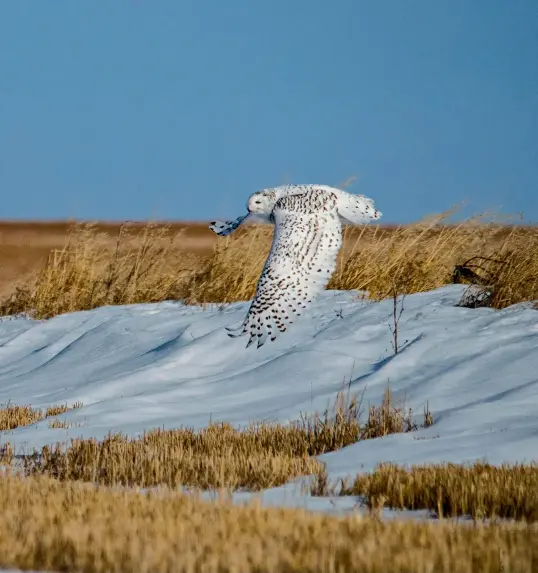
[229,191,342,348]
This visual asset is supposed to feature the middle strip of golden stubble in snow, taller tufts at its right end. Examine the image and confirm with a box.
[5,392,431,491]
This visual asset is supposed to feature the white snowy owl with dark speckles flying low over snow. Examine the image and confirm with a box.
[209,185,381,348]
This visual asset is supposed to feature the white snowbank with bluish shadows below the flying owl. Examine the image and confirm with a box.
[0,286,538,511]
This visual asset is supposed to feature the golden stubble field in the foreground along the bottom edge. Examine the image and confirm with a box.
[0,477,538,573]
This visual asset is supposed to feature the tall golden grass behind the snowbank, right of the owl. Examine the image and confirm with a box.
[329,213,538,308]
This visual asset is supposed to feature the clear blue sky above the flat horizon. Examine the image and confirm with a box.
[0,0,538,222]
